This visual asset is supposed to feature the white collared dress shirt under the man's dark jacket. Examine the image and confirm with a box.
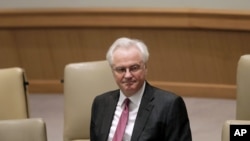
[108,82,146,141]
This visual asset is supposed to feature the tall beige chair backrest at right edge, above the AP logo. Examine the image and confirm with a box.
[236,54,250,120]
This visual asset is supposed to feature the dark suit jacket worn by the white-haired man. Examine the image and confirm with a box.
[90,83,192,141]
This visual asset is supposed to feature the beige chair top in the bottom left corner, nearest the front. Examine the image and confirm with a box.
[0,118,47,141]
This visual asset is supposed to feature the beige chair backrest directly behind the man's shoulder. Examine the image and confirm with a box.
[64,60,117,141]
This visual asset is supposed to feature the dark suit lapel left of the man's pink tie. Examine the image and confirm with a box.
[101,91,119,141]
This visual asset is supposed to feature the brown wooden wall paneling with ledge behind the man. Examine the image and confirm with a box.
[0,10,250,98]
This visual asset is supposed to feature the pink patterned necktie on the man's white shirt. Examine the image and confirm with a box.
[113,98,130,141]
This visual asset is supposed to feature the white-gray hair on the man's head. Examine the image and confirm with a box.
[106,37,149,65]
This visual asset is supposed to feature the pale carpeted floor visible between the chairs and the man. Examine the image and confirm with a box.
[29,94,236,141]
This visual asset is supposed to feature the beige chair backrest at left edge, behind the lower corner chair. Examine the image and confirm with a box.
[0,67,29,120]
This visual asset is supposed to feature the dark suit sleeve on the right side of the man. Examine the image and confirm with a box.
[165,97,192,141]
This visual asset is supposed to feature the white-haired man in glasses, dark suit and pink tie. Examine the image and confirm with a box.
[90,38,192,141]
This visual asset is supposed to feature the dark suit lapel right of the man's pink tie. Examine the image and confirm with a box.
[131,83,154,141]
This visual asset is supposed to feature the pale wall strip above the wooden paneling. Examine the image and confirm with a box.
[0,0,250,10]
